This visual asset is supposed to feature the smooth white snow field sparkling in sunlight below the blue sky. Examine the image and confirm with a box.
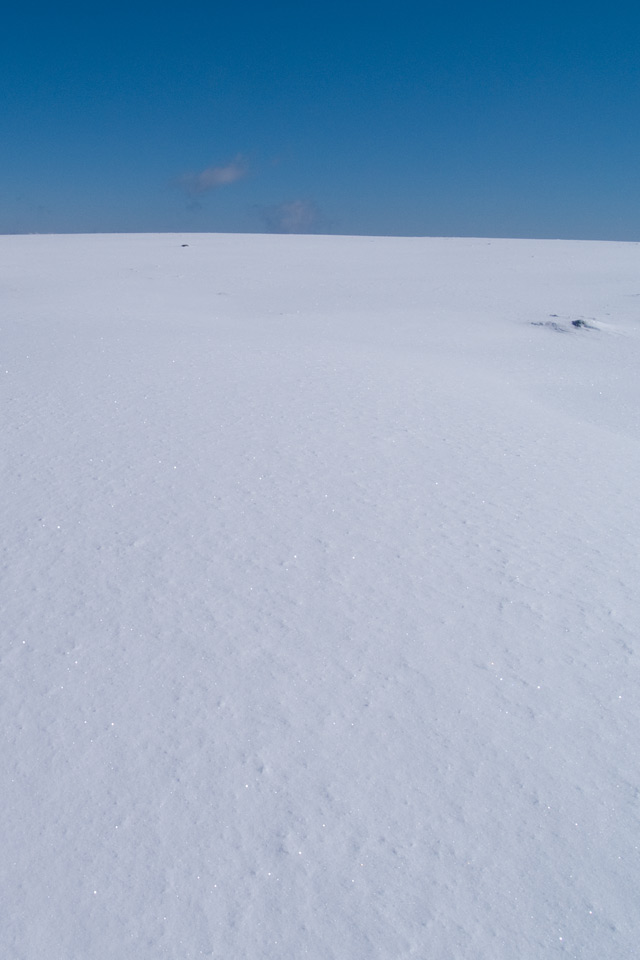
[0,235,640,960]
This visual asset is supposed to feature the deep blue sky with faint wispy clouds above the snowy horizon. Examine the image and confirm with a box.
[0,0,640,240]
